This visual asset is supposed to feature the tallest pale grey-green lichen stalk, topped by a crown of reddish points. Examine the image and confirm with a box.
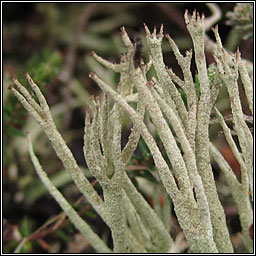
[185,12,232,252]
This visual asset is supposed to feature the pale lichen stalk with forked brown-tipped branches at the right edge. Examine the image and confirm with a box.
[213,28,253,199]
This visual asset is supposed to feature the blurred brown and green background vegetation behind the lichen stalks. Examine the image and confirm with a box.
[2,2,253,253]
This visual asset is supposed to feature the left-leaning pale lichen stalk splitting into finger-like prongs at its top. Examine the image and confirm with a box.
[10,74,105,219]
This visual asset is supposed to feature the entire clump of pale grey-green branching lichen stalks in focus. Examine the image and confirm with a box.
[10,8,253,253]
